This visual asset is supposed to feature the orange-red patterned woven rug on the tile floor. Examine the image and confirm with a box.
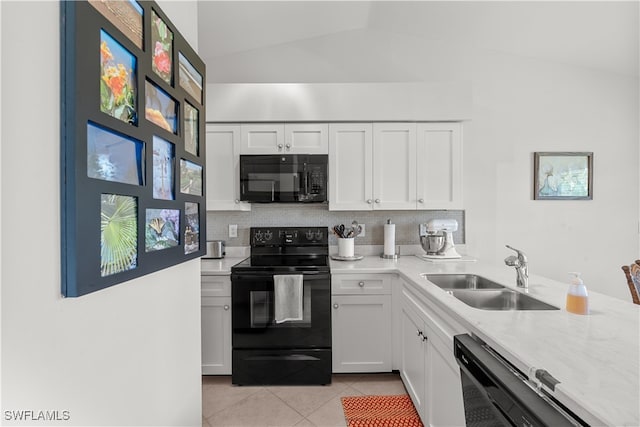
[342,394,423,427]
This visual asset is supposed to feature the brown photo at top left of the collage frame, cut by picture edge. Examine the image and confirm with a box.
[89,0,144,49]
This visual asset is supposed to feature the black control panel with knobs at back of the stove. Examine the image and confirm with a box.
[249,227,329,247]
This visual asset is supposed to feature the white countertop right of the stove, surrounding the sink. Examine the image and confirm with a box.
[331,256,640,426]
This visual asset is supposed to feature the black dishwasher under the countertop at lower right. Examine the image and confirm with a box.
[453,334,588,427]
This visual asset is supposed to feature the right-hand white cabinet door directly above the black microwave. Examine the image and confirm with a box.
[284,123,329,154]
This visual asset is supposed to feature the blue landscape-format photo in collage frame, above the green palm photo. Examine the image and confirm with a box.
[87,122,144,185]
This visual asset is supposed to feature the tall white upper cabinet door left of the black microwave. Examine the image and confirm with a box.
[206,125,251,211]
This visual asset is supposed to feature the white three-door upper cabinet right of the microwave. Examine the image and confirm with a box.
[329,122,463,210]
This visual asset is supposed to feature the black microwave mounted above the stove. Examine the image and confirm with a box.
[240,154,329,203]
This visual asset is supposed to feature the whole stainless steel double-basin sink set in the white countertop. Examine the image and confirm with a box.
[422,274,559,310]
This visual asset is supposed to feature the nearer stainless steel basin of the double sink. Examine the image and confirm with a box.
[447,289,559,310]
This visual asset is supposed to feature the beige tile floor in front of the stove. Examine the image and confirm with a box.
[202,373,406,427]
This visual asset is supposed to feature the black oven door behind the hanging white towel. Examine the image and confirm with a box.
[231,272,331,349]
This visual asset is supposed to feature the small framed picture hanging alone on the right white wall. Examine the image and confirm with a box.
[533,152,593,200]
